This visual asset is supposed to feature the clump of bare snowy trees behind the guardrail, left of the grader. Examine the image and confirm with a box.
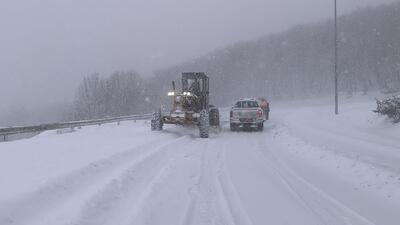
[72,71,151,120]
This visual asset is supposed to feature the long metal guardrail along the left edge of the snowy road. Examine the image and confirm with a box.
[0,113,152,142]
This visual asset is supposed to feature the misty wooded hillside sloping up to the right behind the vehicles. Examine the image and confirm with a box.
[151,2,400,104]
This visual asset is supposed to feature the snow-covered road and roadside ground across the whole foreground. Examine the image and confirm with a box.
[0,97,400,225]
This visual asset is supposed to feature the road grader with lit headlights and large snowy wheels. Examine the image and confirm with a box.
[151,72,220,138]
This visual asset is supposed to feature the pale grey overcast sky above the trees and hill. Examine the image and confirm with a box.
[0,0,391,110]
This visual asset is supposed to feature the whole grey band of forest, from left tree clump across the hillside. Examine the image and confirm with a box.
[73,2,400,119]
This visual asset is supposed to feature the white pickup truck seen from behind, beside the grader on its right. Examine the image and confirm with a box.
[230,98,265,131]
